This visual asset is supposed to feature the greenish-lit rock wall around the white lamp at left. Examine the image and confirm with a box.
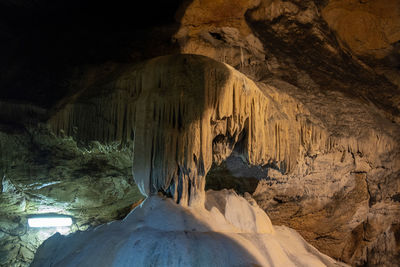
[0,126,142,267]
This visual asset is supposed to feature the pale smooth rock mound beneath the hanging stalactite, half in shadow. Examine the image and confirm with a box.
[32,190,343,267]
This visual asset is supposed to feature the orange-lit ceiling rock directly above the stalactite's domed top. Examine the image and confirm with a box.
[173,0,265,66]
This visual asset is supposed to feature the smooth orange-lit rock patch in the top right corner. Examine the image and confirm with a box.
[322,0,400,59]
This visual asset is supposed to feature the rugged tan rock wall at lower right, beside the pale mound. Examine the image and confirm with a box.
[253,151,400,265]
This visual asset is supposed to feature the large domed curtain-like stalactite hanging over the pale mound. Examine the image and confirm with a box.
[49,55,400,205]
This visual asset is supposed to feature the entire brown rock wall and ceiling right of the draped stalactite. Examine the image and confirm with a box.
[175,1,400,265]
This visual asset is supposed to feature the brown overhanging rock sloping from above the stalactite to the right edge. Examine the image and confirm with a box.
[175,0,400,123]
